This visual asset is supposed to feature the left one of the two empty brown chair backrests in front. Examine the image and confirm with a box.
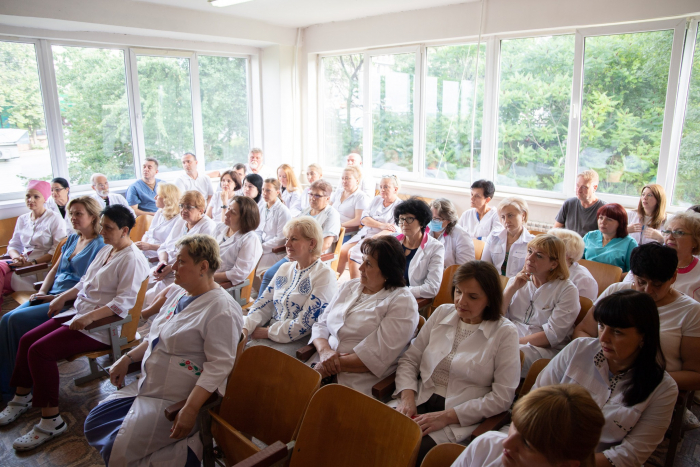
[219,345,321,456]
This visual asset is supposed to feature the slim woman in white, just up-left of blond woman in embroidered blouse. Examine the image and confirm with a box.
[255,178,292,271]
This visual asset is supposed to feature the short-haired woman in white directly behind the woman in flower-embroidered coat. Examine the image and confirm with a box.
[144,190,216,306]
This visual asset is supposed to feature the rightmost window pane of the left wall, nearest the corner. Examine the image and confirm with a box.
[197,55,249,170]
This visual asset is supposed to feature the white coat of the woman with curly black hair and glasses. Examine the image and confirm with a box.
[396,229,445,298]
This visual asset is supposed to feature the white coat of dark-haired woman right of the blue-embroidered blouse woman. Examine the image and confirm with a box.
[308,279,418,396]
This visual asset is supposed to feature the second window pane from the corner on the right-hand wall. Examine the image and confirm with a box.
[370,53,416,172]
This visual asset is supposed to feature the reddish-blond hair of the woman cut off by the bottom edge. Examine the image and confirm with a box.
[512,384,605,467]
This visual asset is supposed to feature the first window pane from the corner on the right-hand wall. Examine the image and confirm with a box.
[321,54,364,167]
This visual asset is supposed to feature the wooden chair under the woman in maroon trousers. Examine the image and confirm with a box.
[66,278,148,386]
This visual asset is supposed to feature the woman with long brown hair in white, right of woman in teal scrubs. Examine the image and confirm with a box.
[627,183,666,245]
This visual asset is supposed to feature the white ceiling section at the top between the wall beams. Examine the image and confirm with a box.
[136,0,479,28]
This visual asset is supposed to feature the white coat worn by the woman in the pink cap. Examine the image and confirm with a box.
[7,209,66,292]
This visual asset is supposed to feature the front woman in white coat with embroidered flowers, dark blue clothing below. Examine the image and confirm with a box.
[85,234,242,467]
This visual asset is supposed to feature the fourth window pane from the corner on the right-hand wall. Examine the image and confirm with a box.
[495,35,575,192]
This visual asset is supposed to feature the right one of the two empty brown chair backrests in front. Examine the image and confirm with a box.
[289,384,421,467]
